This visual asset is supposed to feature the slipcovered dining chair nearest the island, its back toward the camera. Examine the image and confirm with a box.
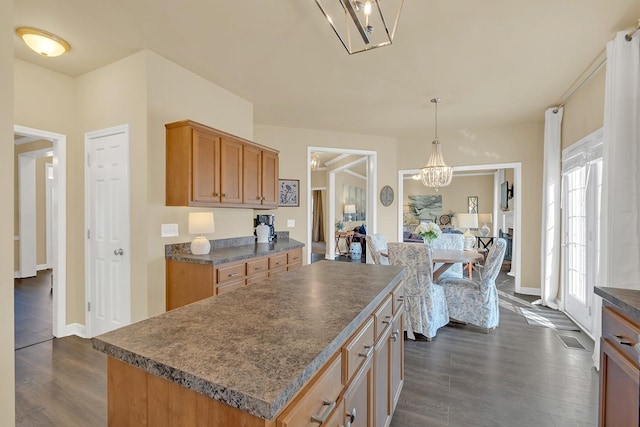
[388,242,449,341]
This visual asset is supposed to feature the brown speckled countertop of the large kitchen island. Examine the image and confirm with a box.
[93,261,402,419]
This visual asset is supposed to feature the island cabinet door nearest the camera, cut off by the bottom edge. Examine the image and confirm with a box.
[344,357,374,427]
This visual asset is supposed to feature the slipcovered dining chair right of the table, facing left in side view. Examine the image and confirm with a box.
[438,239,507,330]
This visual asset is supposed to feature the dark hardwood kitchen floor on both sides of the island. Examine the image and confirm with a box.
[15,268,598,427]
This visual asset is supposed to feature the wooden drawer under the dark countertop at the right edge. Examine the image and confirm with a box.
[602,305,640,367]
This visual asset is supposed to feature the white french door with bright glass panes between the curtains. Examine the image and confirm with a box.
[562,133,602,333]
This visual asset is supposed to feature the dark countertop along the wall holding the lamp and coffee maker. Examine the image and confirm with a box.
[165,238,304,265]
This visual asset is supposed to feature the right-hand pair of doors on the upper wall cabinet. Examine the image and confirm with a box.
[243,145,278,208]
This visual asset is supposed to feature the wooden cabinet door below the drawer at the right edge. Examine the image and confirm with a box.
[599,340,640,427]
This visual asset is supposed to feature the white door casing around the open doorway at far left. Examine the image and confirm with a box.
[13,125,69,337]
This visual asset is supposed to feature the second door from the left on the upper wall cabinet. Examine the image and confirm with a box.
[220,137,243,204]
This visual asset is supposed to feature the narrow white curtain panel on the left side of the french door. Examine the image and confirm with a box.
[534,107,563,310]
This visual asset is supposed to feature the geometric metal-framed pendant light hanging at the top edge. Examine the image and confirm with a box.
[316,0,404,55]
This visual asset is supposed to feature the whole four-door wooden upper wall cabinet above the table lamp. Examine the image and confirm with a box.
[165,120,278,209]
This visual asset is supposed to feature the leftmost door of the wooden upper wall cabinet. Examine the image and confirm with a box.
[191,129,220,204]
